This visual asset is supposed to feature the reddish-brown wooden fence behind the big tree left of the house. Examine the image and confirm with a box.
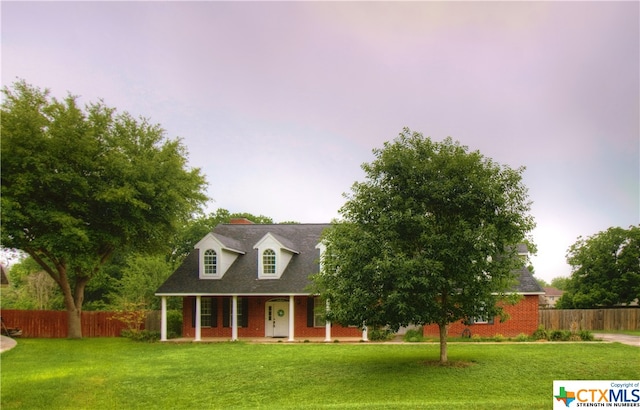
[0,310,152,338]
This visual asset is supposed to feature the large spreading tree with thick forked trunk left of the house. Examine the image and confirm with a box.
[1,81,207,338]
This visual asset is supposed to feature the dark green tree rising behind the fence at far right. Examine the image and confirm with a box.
[556,226,640,309]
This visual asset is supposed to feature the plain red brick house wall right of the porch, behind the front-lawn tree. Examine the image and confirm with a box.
[423,295,538,337]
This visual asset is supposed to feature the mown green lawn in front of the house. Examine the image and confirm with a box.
[0,338,640,410]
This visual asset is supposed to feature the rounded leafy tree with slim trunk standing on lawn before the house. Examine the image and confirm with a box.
[315,129,534,362]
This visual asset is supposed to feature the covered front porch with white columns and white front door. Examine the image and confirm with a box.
[160,294,368,342]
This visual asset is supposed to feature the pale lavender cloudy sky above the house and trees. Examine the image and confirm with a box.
[0,1,640,282]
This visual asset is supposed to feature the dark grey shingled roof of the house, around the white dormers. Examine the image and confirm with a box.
[156,224,544,296]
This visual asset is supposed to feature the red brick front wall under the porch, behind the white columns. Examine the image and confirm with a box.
[182,296,362,339]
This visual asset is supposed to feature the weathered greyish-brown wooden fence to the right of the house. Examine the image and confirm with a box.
[539,308,640,330]
